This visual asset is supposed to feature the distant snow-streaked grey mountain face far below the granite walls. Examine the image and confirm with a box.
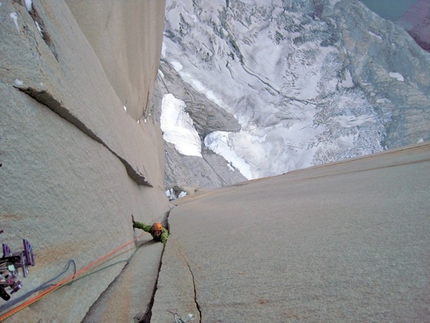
[157,0,430,195]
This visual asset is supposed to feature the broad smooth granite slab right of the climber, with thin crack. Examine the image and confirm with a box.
[151,143,430,323]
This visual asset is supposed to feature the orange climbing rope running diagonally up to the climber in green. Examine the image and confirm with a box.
[0,232,146,322]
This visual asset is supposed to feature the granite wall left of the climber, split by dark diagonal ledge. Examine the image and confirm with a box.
[0,0,171,322]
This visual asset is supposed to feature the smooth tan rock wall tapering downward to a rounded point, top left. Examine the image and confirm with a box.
[66,0,165,120]
